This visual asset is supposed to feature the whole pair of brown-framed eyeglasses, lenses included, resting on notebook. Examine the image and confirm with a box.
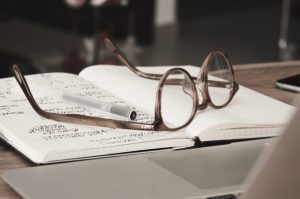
[13,39,239,131]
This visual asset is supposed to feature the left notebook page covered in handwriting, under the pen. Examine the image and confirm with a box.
[0,73,193,163]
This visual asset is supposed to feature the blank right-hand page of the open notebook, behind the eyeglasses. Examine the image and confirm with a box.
[80,65,294,140]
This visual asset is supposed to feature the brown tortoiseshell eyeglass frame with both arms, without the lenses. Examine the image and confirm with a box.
[12,39,239,131]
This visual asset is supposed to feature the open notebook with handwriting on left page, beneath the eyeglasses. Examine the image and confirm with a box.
[0,65,294,163]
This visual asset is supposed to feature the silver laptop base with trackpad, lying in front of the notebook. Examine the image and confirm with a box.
[2,109,300,199]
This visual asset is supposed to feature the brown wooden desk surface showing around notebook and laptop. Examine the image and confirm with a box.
[0,61,300,198]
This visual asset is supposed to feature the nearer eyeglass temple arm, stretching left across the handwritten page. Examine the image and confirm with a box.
[13,65,155,130]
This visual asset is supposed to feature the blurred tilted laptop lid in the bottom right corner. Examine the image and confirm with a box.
[243,105,300,199]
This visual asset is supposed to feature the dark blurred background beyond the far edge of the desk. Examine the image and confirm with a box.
[0,0,300,77]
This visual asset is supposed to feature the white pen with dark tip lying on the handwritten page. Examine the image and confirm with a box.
[62,93,136,120]
